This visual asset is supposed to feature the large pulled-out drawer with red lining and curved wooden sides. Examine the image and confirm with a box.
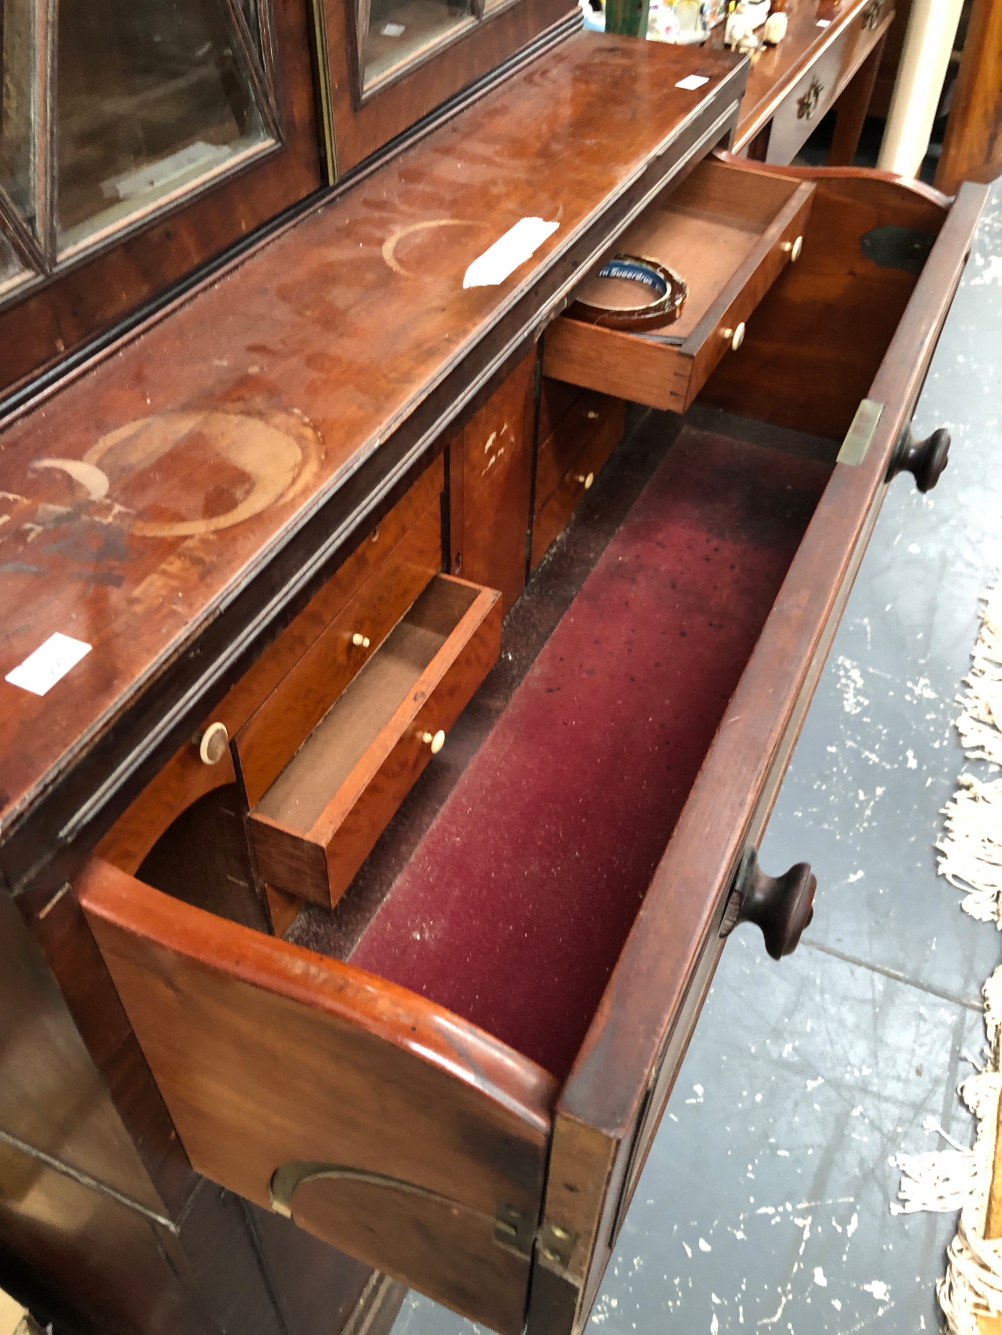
[75,174,986,1335]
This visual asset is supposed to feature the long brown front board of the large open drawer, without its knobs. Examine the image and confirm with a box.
[528,179,986,1335]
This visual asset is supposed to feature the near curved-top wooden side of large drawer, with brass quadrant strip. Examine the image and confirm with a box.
[77,860,555,1335]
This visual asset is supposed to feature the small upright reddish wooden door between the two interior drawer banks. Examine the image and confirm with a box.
[448,348,538,615]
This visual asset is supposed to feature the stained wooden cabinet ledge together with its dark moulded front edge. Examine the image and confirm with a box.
[0,35,744,885]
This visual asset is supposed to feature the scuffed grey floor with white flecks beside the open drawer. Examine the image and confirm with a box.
[394,187,1002,1335]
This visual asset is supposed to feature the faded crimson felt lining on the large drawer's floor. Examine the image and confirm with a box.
[352,429,831,1079]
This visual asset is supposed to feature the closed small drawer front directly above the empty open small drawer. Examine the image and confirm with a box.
[236,501,442,806]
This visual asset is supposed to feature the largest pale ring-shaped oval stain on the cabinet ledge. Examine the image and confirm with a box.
[83,411,320,538]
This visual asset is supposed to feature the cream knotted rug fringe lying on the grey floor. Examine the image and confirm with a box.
[890,579,1002,1335]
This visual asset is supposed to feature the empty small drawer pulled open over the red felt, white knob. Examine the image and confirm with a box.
[251,575,500,905]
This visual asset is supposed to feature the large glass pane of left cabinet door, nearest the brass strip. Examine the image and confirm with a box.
[56,0,267,248]
